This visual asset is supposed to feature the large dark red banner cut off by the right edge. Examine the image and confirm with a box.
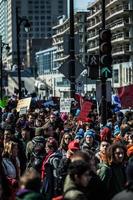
[117,85,133,108]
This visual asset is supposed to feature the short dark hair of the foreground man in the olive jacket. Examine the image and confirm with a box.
[68,160,90,181]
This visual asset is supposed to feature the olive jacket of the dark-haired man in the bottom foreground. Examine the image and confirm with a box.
[64,175,87,200]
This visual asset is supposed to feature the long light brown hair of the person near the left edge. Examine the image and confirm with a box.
[2,141,18,158]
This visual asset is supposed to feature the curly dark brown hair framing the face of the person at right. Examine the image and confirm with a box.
[106,142,127,164]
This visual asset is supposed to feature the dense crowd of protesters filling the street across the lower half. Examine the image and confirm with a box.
[0,96,133,200]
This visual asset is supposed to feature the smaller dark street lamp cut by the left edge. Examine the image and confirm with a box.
[0,37,10,100]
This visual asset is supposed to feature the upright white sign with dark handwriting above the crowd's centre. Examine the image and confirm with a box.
[60,98,71,113]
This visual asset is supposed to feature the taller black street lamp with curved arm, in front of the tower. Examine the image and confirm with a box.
[16,8,30,99]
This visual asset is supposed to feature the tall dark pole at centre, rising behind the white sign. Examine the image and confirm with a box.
[69,0,75,98]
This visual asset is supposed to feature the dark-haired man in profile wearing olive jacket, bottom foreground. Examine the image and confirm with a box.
[64,160,90,200]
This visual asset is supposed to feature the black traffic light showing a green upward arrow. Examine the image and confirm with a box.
[99,29,112,78]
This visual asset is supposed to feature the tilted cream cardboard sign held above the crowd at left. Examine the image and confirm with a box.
[16,97,31,112]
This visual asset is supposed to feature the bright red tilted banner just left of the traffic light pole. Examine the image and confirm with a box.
[78,101,93,122]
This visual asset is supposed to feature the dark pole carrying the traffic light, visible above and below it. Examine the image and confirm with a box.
[101,0,107,126]
